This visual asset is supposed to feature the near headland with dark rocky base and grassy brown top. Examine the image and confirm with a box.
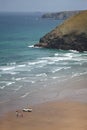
[35,11,87,51]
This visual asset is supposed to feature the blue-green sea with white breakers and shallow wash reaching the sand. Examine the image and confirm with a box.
[0,13,87,116]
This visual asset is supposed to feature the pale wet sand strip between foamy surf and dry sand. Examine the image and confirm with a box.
[0,76,87,116]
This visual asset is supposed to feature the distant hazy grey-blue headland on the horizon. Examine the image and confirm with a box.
[42,11,80,20]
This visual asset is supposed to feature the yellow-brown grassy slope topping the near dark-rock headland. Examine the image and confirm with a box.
[51,11,87,36]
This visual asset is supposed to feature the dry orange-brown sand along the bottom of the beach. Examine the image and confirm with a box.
[0,101,87,130]
